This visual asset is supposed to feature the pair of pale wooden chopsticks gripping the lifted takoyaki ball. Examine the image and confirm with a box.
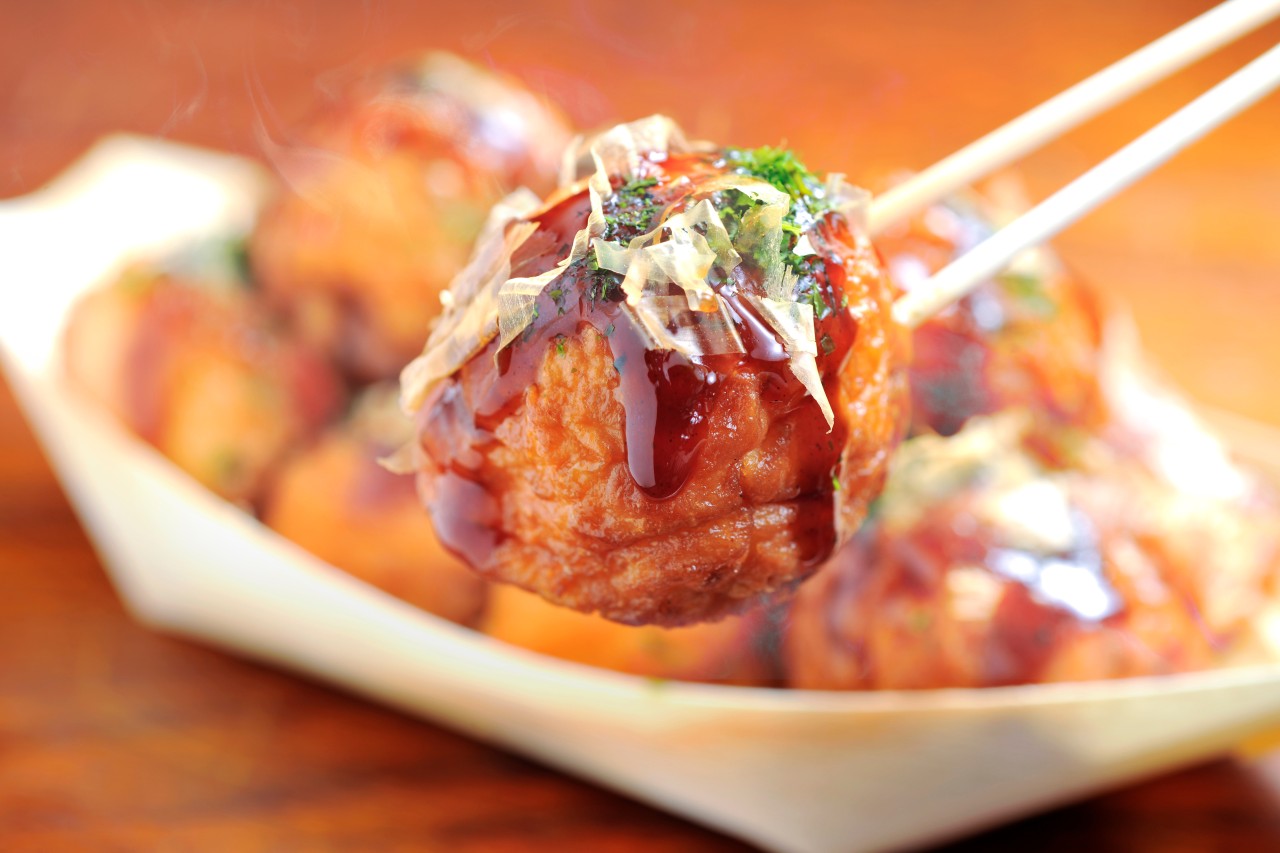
[868,0,1280,328]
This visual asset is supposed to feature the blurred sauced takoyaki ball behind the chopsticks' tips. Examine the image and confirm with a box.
[876,179,1105,435]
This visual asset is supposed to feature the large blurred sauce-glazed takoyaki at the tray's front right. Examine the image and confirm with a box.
[785,412,1280,689]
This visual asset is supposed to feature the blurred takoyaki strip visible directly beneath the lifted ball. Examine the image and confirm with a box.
[480,584,780,686]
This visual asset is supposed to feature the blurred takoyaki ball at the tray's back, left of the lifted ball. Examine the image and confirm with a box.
[250,54,570,380]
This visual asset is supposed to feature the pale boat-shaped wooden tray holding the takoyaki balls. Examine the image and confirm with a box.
[0,137,1280,852]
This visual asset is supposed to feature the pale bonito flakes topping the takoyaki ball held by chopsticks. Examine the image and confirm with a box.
[401,115,868,427]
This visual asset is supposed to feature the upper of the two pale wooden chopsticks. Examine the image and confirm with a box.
[868,0,1280,234]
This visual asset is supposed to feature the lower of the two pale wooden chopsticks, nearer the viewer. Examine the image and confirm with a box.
[893,45,1280,328]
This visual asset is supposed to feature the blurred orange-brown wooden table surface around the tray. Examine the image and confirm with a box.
[0,0,1280,850]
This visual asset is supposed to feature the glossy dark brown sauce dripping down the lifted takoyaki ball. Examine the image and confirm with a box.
[421,154,858,565]
